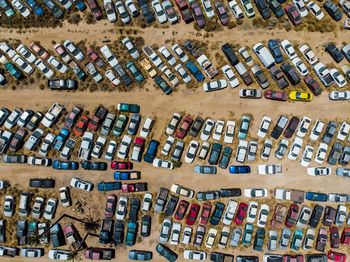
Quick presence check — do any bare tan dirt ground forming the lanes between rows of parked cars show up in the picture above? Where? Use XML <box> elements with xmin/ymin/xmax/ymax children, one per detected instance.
<box><xmin>0</xmin><ymin>18</ymin><xmax>350</xmax><ymax>261</ymax></box>
